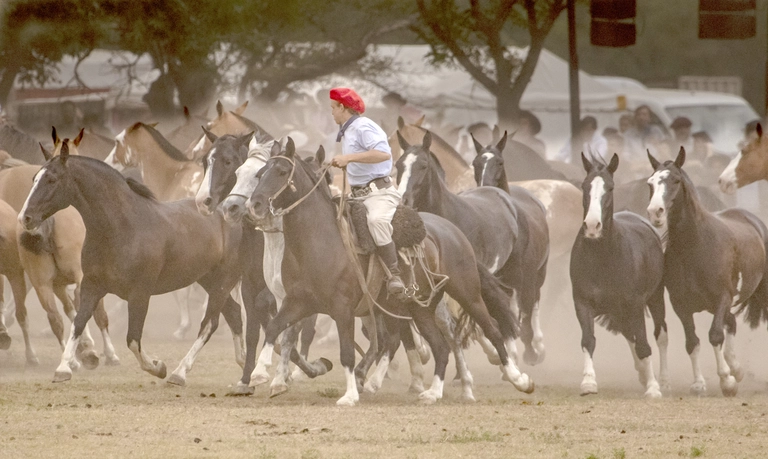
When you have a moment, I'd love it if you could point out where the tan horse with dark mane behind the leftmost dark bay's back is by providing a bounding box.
[105,122,203,201]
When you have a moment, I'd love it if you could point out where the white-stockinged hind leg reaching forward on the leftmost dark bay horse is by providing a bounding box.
[167,292,236,386]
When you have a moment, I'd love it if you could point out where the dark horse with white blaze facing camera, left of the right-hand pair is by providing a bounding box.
[571,153,668,398]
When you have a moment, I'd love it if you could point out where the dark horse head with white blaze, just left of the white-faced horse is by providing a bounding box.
[195,128,253,215]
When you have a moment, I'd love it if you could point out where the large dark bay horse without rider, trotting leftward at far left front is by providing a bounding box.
[19,144,243,382]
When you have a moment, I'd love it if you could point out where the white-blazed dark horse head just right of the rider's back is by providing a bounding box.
[395,131,445,208]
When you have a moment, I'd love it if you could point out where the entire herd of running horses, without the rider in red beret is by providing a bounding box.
[0,103,768,405]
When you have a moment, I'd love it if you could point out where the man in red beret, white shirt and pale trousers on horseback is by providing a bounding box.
[330,88,405,299]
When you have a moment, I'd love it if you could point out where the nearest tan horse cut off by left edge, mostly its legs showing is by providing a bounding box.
[0,200,31,366]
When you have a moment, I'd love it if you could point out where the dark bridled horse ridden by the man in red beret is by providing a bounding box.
[242,142,533,405]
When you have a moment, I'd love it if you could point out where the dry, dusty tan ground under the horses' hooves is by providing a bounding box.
[0,290,768,459]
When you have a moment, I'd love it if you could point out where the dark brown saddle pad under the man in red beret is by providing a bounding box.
[347,201,427,255]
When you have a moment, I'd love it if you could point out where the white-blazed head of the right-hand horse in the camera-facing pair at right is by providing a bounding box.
[648,147,687,231]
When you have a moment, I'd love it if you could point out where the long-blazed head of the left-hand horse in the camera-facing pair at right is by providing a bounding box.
[581,152,619,239]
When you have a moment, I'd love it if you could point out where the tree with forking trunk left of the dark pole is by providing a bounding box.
[414,0,566,126]
